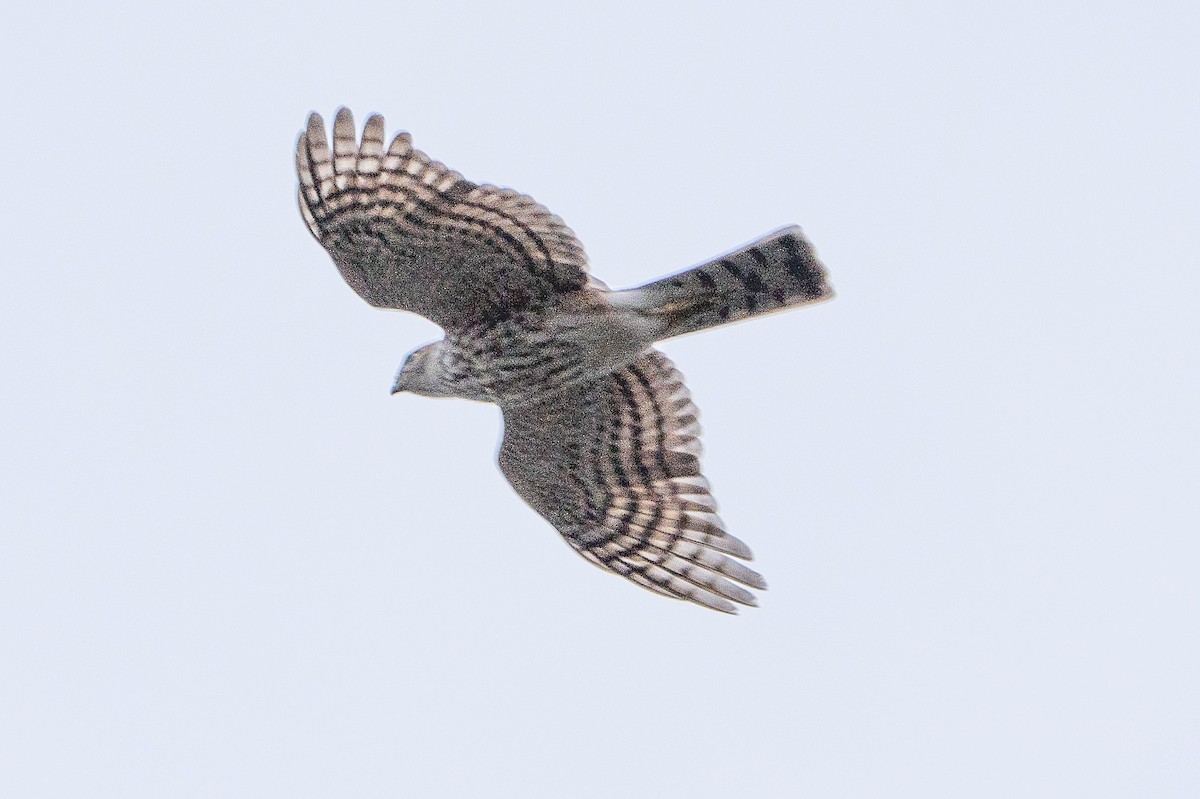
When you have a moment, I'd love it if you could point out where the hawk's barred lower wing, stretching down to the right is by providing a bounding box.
[500,350,767,613]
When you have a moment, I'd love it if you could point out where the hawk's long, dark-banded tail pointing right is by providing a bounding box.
[610,224,833,338]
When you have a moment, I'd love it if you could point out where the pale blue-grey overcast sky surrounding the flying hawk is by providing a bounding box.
[0,1,1200,799]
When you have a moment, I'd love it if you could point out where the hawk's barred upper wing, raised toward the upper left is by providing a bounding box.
[296,108,588,329]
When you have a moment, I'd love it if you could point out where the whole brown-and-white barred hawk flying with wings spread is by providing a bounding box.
[296,108,833,613]
